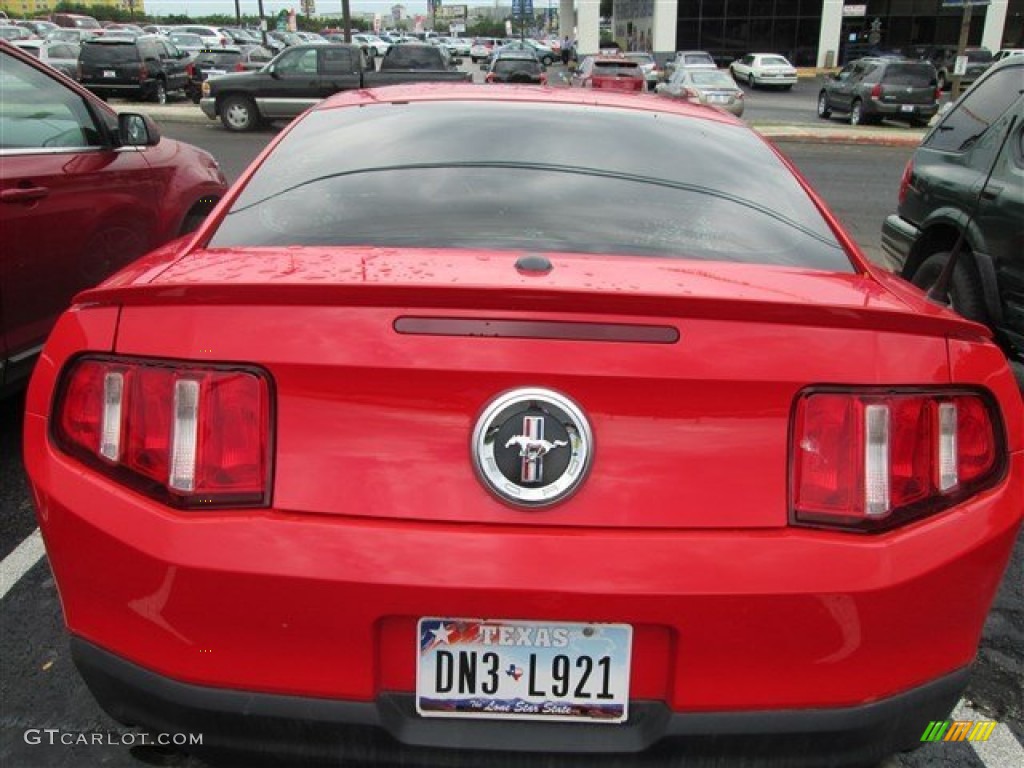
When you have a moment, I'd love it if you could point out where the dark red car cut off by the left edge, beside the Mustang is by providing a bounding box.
[0,43,227,393]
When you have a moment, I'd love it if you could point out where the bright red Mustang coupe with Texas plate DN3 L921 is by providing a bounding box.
[25,85,1024,766]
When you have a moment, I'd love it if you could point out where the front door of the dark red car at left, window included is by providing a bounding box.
[0,51,159,385]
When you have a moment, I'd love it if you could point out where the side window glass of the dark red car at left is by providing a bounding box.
[0,49,102,150]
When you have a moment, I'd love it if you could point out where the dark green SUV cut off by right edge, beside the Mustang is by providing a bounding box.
[882,56,1024,370]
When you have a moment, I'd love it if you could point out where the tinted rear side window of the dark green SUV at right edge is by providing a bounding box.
[925,67,1024,152]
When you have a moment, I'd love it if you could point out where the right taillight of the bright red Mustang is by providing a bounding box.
[791,391,1002,530]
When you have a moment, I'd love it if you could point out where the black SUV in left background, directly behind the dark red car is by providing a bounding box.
[78,35,191,104]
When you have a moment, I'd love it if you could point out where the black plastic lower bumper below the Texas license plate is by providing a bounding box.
[72,638,969,768]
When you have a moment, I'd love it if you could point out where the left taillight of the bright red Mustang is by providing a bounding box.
[53,357,271,508]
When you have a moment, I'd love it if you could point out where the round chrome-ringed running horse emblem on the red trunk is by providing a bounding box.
[472,388,594,507]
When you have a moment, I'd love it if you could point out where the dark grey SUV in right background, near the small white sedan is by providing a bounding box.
[818,57,942,126]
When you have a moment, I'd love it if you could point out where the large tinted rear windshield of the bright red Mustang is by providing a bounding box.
[210,100,853,272]
